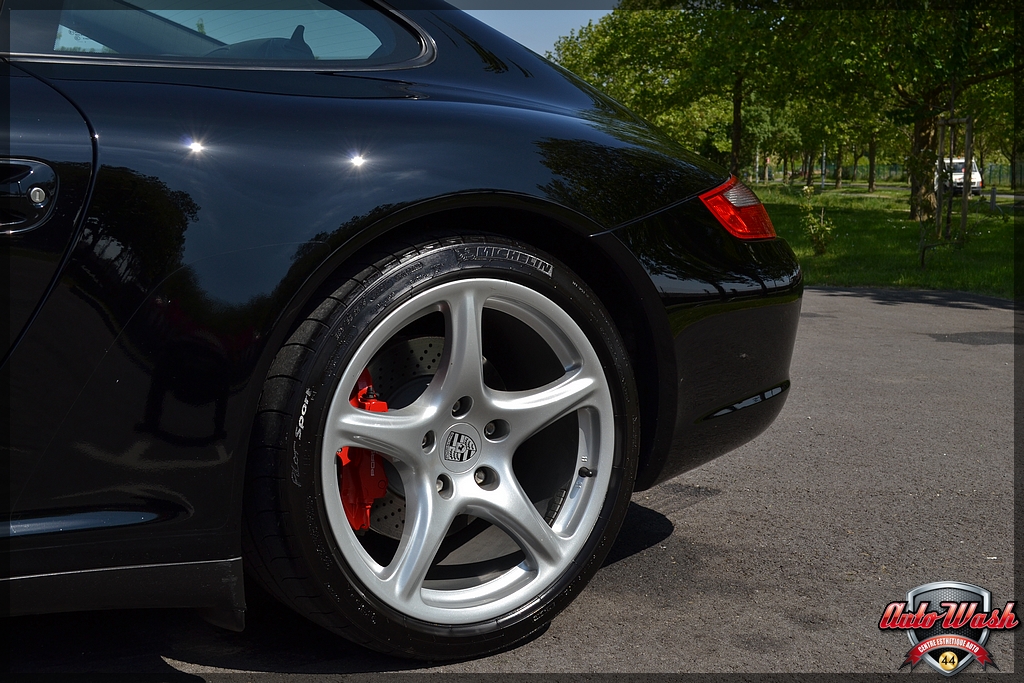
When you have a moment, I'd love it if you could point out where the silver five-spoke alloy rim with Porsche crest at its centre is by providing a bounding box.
[319,279,615,625]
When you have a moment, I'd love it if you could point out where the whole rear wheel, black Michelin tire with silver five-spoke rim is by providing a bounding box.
[244,236,639,660]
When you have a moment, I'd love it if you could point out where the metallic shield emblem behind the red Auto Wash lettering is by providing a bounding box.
[906,581,992,676]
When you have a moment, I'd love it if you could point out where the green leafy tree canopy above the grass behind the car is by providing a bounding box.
[550,5,1021,206]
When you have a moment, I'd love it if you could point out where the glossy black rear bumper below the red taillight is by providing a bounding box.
[614,197,803,489]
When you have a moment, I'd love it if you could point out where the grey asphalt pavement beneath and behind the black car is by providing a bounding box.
[5,290,1024,681]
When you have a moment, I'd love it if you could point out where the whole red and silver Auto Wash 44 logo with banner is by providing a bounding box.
[879,581,1019,676]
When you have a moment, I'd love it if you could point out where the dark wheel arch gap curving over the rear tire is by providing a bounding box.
[240,193,676,528]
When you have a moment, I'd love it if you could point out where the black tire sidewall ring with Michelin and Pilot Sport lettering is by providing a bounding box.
[283,238,639,658]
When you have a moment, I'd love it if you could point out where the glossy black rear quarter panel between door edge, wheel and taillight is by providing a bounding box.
[9,58,721,575]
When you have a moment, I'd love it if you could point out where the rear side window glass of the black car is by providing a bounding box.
[4,0,426,69]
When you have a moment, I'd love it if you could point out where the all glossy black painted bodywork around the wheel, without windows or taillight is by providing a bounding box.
[4,1,801,611]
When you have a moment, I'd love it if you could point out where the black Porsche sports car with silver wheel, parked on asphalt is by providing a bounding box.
[0,0,802,659]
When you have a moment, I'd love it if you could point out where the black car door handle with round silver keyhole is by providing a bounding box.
[0,159,57,233]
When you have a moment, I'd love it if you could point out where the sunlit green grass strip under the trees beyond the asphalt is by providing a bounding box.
[753,184,1014,299]
